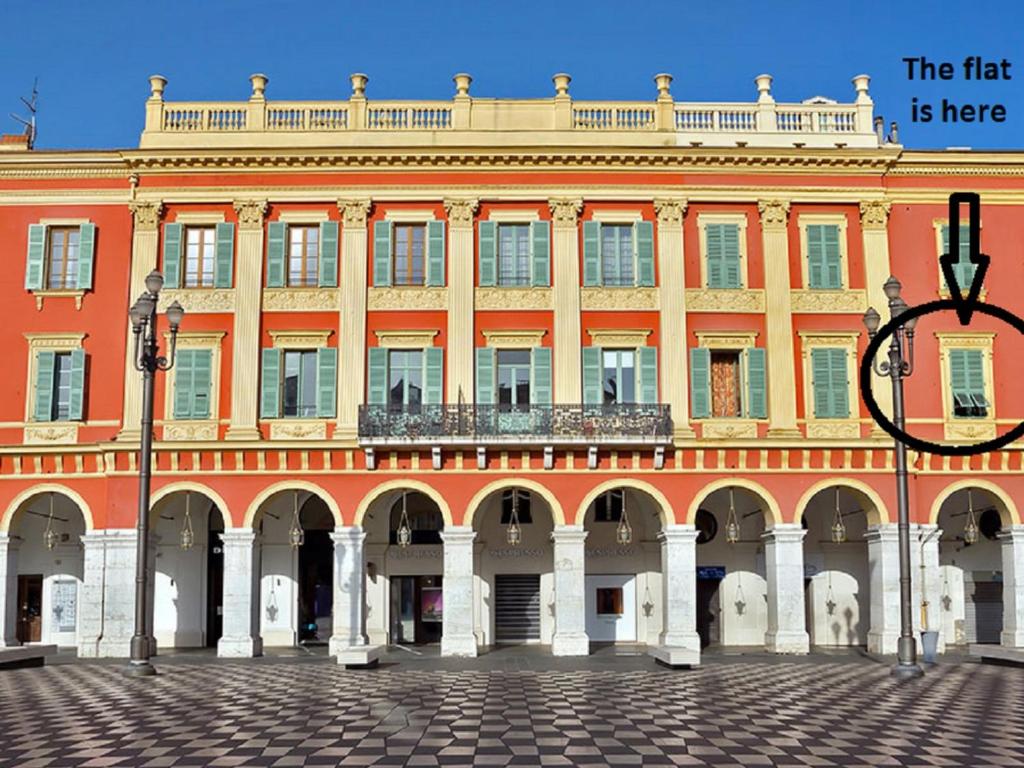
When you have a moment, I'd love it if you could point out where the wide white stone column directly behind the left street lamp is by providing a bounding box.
[78,528,135,658]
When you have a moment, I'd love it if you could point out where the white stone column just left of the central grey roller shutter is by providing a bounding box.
[441,525,476,656]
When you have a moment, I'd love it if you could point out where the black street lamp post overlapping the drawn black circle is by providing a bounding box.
[864,278,924,678]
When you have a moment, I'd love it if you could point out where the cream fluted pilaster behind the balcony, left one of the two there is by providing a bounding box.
[444,200,479,403]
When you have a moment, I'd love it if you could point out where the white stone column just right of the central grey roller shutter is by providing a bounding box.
[551,525,590,656]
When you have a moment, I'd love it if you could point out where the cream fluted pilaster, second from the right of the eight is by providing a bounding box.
[758,200,800,437]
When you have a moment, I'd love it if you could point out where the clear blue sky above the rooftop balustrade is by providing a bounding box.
[0,0,1024,148]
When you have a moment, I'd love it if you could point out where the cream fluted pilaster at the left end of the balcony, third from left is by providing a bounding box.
[334,200,372,441]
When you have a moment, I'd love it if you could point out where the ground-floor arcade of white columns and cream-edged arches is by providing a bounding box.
[0,474,1024,656]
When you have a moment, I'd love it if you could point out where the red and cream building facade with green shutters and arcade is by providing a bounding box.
[0,75,1024,656]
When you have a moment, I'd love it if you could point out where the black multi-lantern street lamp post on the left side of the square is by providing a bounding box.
[127,269,185,675]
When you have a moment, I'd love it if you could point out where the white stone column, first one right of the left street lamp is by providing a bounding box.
[217,528,263,657]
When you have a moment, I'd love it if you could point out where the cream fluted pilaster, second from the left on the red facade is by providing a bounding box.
[225,200,267,440]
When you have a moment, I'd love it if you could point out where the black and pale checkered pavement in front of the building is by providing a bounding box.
[0,657,1024,768]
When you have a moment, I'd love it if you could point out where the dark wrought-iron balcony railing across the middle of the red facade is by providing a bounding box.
[359,403,672,445]
